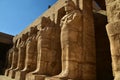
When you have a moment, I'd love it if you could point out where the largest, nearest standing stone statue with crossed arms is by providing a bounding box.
[45,0,83,80]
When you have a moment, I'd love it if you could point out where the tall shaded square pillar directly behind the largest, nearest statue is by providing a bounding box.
[82,0,96,80]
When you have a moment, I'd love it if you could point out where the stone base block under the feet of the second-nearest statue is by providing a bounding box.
[26,73,46,80]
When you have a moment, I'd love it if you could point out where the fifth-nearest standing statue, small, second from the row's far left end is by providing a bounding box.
[5,39,20,76]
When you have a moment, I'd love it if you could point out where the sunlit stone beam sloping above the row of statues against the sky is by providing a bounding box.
[14,0,83,39]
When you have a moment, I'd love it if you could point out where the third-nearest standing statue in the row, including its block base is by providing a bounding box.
[15,26,38,80]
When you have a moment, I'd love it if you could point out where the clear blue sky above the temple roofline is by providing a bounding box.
[0,0,57,35]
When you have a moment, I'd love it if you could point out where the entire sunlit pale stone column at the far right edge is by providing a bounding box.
[106,0,120,80]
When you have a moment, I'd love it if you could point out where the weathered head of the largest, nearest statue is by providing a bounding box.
[65,0,75,12]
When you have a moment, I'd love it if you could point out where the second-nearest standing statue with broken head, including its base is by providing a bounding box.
[27,17,61,80]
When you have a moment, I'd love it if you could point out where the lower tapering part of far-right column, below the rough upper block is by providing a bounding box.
[106,21,120,80]
